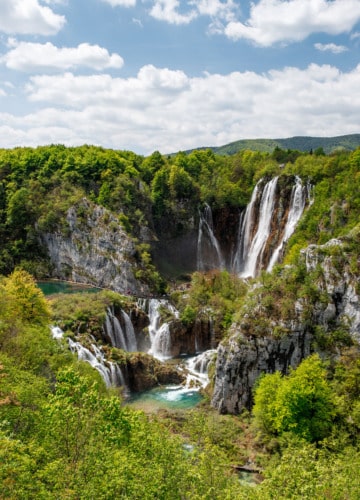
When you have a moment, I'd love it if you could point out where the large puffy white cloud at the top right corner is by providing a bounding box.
[224,0,360,47]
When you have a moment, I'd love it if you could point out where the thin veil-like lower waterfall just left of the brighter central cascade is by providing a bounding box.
[104,307,137,352]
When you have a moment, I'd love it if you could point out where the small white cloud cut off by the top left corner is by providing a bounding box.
[0,0,66,35]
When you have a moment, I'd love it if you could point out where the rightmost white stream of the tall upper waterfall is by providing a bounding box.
[267,176,307,271]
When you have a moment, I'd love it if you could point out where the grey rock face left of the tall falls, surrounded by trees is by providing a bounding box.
[40,199,148,294]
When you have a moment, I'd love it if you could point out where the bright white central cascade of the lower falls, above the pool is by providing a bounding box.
[148,299,179,360]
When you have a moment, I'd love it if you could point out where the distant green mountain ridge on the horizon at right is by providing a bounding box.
[188,134,360,155]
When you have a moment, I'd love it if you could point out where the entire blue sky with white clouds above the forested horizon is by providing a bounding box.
[0,0,360,156]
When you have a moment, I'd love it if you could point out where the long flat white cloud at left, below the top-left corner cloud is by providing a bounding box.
[0,39,124,72]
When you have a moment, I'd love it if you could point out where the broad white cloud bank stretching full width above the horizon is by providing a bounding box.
[0,64,360,154]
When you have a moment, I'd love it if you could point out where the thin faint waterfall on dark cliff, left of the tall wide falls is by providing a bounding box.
[197,204,225,271]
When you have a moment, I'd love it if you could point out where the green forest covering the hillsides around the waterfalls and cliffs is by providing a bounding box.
[0,145,360,500]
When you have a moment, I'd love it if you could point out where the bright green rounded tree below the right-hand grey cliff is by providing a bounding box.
[253,355,336,442]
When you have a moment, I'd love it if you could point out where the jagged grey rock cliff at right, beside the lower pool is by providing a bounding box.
[212,236,360,414]
